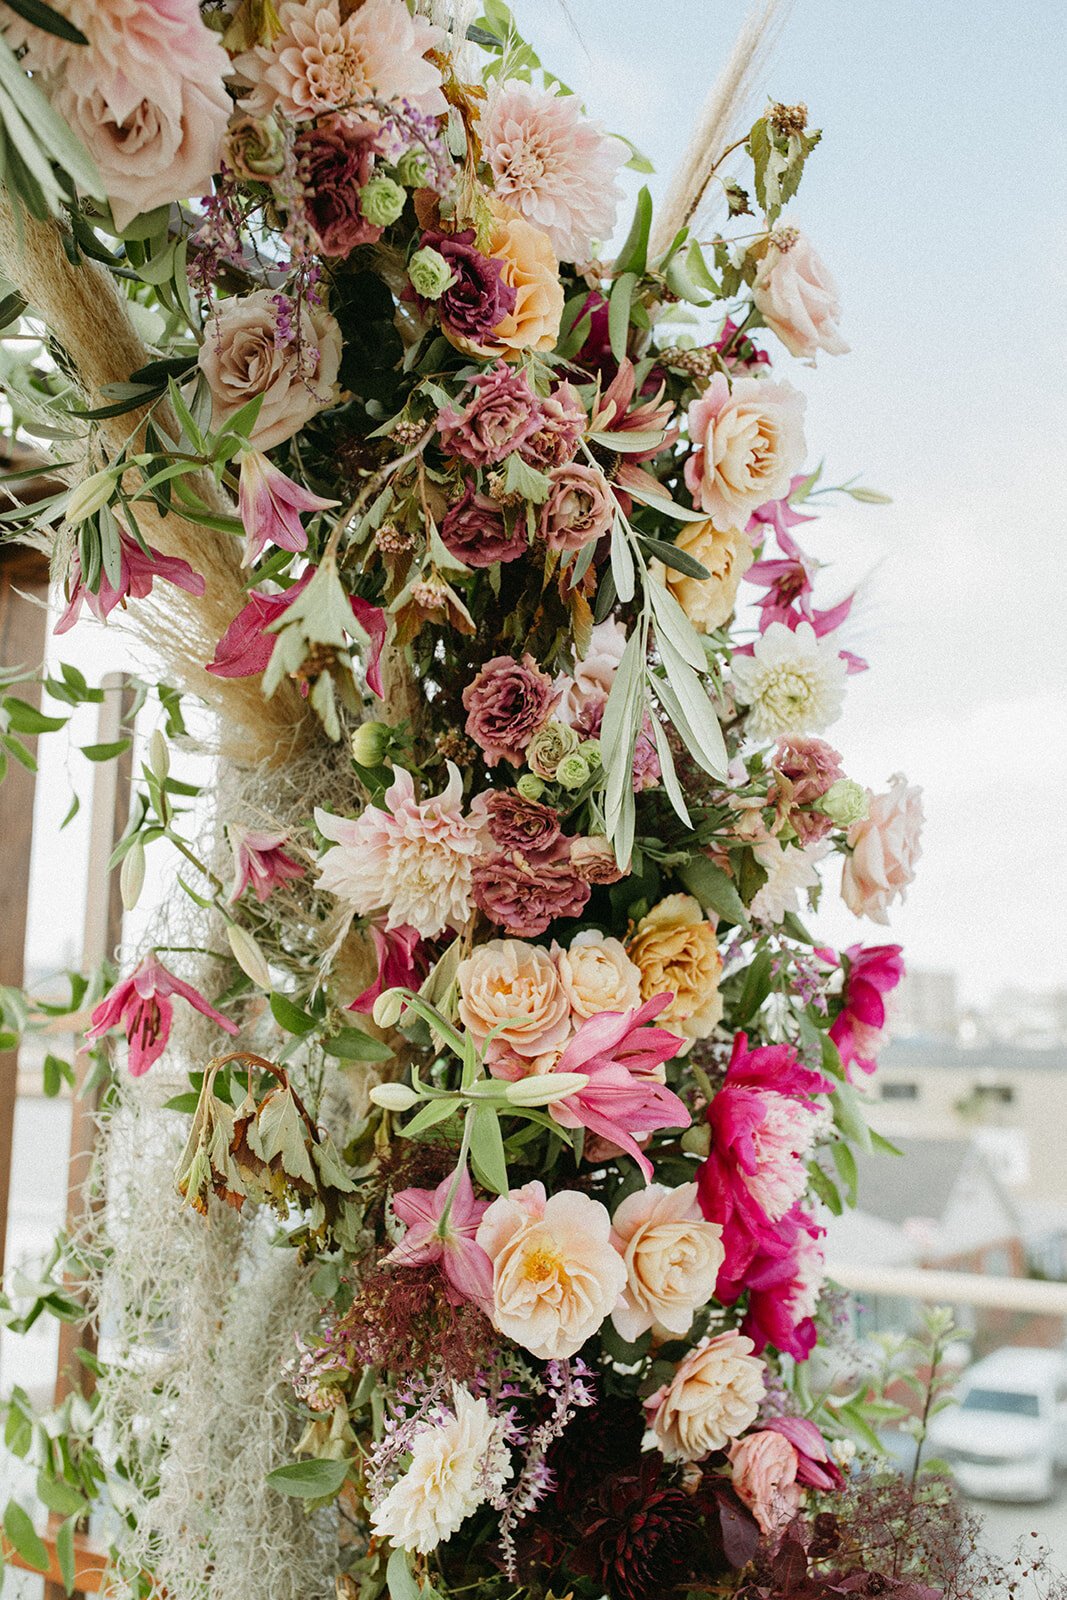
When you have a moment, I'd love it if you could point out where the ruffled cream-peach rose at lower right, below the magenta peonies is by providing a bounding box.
[645,1331,765,1461]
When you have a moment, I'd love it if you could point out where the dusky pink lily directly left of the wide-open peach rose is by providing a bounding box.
[386,1166,493,1315]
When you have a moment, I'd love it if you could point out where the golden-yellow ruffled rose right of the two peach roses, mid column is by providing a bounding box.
[629,894,723,1040]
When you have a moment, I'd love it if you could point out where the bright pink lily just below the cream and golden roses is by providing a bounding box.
[549,994,693,1179]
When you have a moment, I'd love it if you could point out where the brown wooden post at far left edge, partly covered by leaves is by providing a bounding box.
[0,544,48,1274]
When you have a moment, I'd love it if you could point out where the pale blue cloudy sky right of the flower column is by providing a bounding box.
[517,0,1067,1000]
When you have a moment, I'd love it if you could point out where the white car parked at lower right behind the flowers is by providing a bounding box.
[928,1346,1067,1501]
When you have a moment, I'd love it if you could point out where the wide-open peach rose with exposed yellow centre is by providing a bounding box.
[477,1182,625,1362]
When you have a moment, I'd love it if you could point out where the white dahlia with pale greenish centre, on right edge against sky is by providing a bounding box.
[733,622,848,744]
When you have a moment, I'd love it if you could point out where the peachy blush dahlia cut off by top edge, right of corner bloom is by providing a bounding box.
[234,0,446,122]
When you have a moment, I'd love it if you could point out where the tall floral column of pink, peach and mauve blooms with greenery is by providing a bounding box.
[0,0,934,1600]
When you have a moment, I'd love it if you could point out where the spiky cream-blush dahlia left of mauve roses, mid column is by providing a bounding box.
[315,762,478,939]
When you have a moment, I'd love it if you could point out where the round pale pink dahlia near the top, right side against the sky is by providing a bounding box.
[480,80,627,261]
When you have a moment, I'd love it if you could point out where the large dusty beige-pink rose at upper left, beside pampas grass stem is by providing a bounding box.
[197,290,341,450]
